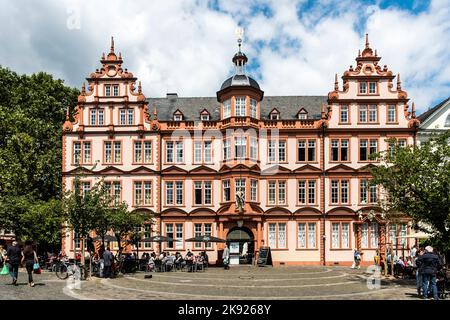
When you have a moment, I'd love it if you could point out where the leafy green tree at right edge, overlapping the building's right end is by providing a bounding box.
[371,130,450,258]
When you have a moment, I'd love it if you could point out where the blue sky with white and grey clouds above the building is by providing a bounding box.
[0,0,450,111]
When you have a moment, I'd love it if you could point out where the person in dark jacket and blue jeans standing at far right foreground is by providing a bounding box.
[417,246,442,300]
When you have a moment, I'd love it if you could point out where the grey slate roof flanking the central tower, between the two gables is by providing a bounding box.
[147,94,327,121]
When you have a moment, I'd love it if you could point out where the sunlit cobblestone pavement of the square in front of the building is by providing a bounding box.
[0,267,424,300]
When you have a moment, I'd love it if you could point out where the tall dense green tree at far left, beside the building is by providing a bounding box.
[0,66,79,243]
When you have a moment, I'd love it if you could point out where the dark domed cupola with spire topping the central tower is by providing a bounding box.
[217,28,264,102]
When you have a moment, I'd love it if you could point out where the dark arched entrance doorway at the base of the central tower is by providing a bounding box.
[227,227,255,264]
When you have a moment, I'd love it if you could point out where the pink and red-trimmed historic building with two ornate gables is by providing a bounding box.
[62,36,419,265]
